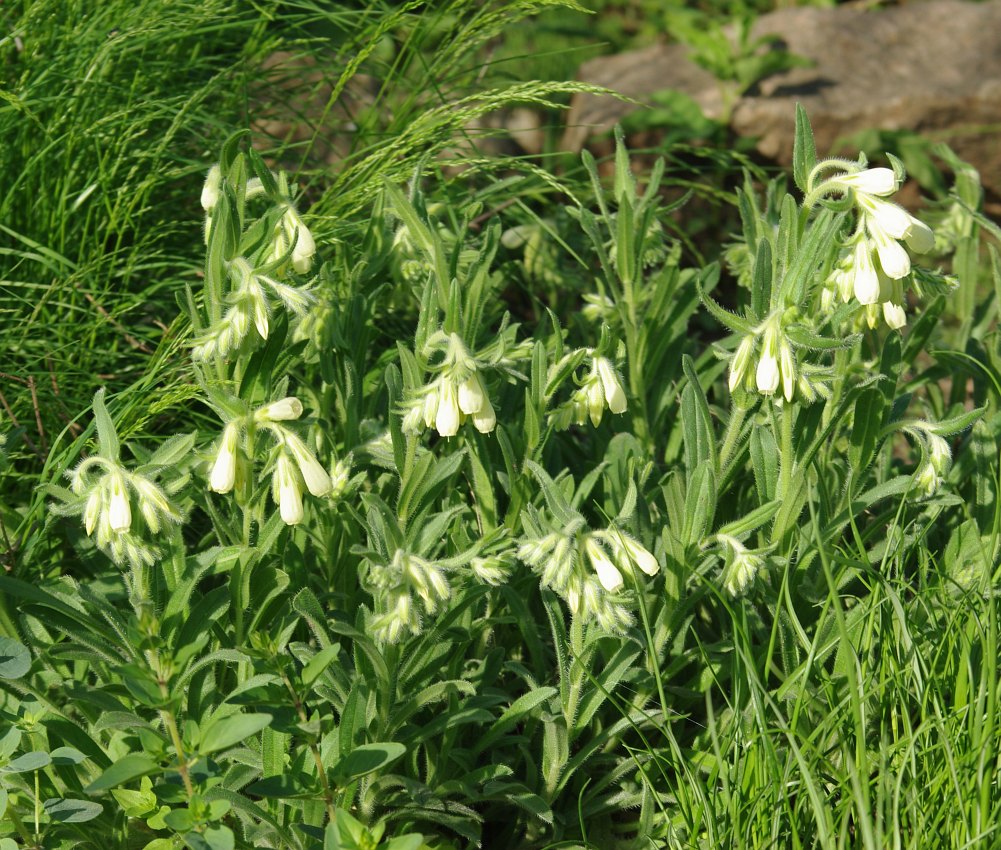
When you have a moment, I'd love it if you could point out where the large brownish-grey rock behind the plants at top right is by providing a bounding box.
[564,0,1001,195]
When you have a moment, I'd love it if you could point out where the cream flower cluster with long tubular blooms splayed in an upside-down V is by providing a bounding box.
[208,396,333,526]
